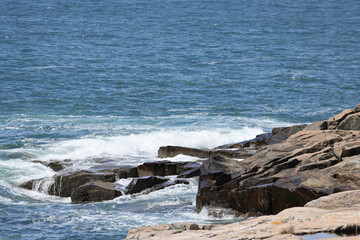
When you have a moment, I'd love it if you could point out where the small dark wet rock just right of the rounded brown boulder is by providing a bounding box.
[126,176,170,194]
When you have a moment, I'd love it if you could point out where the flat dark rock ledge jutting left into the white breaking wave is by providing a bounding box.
[158,146,209,158]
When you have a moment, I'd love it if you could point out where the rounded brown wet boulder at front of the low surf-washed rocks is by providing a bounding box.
[71,181,122,203]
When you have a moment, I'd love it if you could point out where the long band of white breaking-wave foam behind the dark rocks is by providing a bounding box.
[31,127,263,160]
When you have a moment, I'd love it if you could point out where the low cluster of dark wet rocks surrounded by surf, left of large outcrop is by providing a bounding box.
[20,161,200,203]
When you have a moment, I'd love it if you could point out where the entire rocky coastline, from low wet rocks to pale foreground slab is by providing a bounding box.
[21,103,360,239]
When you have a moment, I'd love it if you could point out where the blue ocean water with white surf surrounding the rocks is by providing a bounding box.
[0,0,360,239]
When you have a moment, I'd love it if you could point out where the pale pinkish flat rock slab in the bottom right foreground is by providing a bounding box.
[126,207,360,240]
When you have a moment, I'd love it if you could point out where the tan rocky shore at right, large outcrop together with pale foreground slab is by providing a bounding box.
[126,103,360,240]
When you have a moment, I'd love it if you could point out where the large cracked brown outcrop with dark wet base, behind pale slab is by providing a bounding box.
[196,102,360,214]
